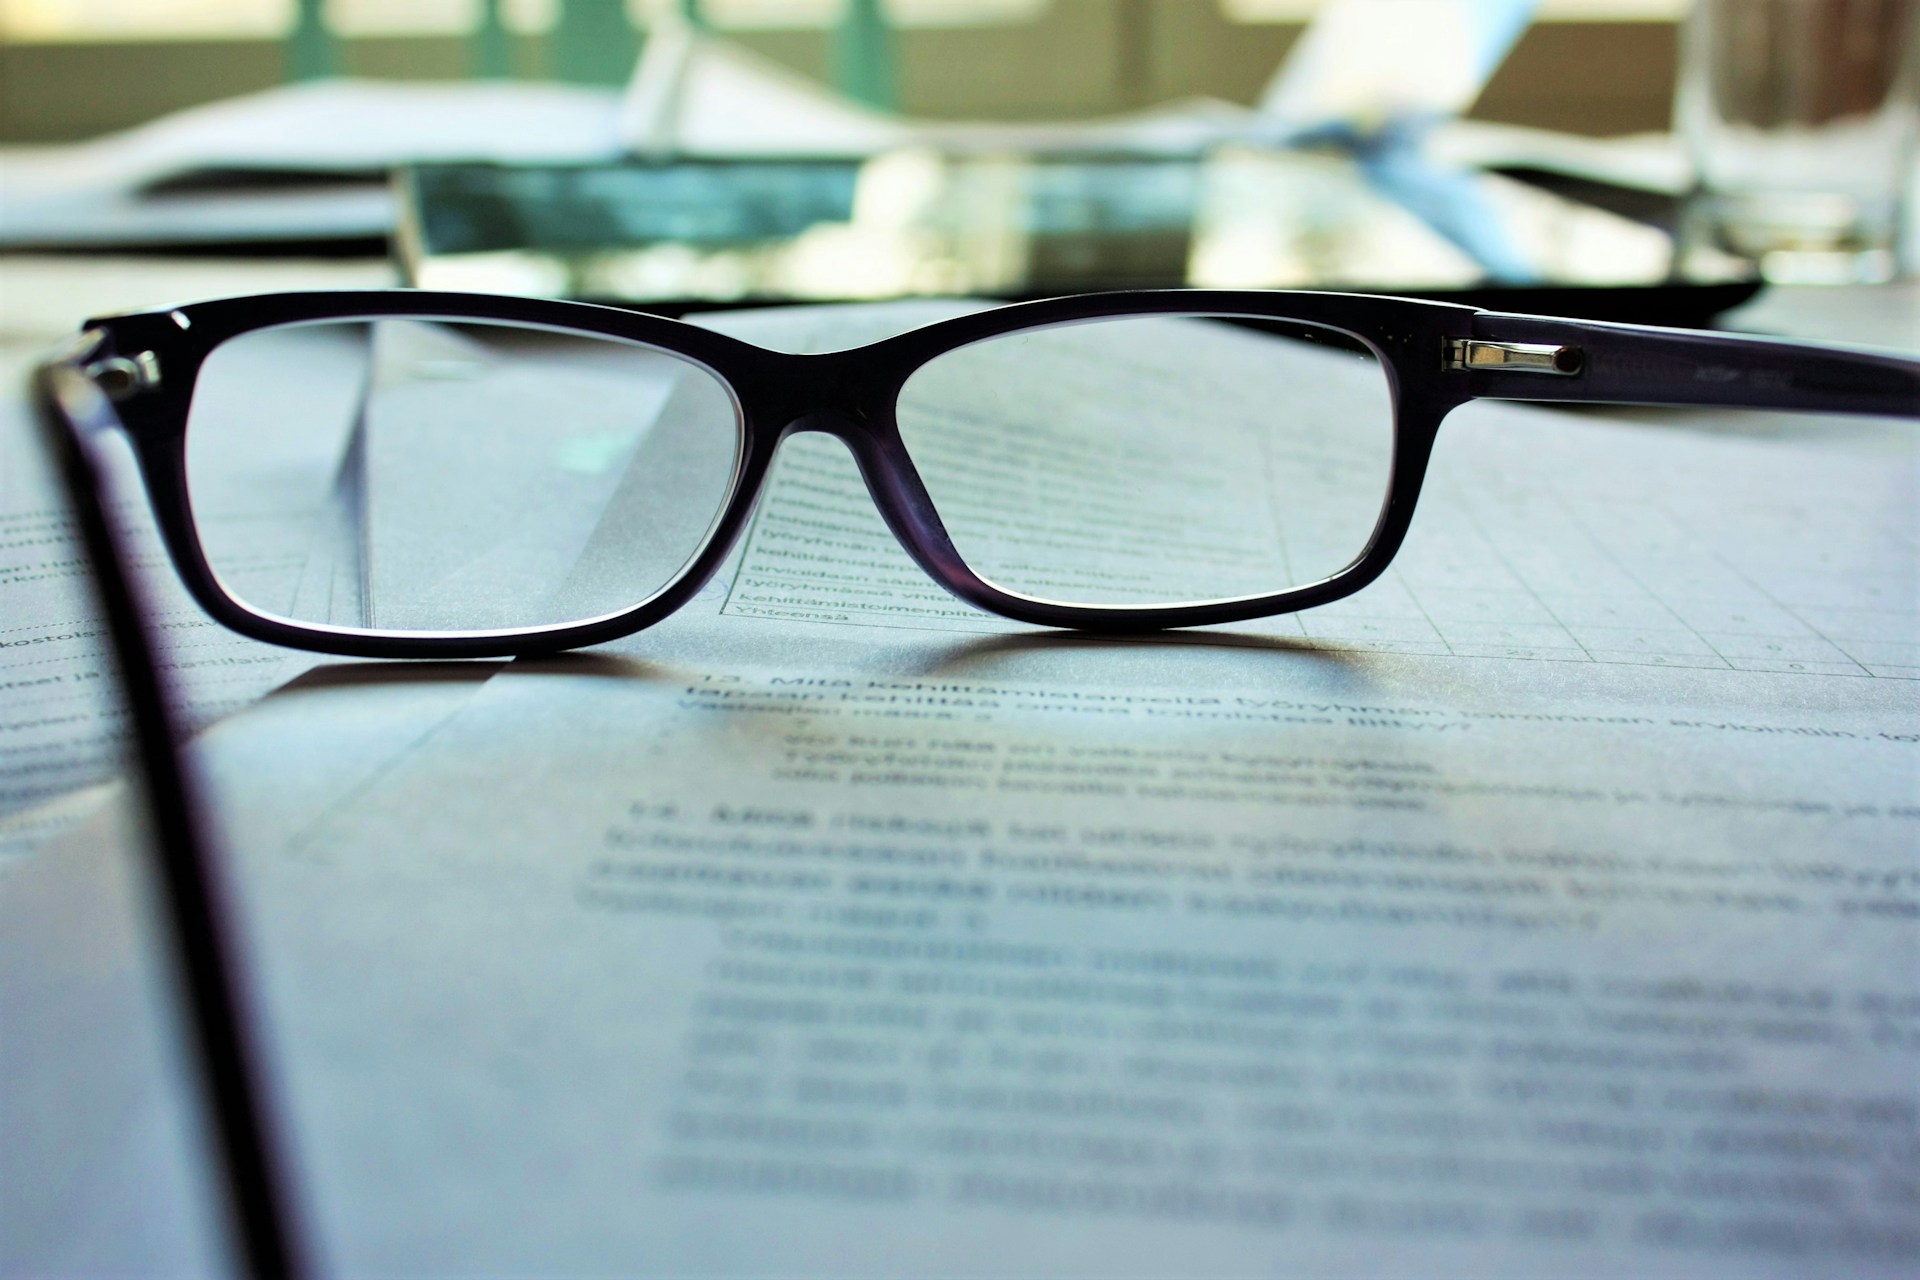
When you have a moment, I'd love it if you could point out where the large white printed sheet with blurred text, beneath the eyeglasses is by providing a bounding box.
[7,297,1920,1278]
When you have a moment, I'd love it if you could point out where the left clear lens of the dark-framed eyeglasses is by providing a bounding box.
[186,319,741,631]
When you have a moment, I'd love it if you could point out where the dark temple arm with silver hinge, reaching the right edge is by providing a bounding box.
[1442,311,1920,418]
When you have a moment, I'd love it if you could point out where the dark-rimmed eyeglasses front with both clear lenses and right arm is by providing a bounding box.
[40,290,1920,658]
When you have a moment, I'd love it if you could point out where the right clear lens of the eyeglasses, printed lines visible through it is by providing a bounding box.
[899,317,1394,606]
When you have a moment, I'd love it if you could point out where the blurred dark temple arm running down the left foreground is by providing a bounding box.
[29,343,309,1278]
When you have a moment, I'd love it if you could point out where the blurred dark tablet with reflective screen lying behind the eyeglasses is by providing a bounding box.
[396,148,1759,326]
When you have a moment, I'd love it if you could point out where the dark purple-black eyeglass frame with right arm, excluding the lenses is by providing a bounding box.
[42,290,1920,658]
